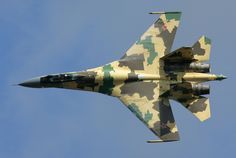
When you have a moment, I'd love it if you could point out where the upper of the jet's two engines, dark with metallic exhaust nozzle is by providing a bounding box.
[164,62,210,73]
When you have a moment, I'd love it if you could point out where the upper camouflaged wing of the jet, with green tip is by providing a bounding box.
[121,12,181,71]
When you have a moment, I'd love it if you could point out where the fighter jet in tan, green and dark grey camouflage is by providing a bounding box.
[19,12,226,143]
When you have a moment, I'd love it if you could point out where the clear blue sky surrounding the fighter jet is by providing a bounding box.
[0,0,236,158]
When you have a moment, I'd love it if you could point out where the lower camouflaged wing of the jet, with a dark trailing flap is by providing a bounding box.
[119,81,179,141]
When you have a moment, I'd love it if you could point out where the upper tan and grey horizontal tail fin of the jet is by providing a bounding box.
[192,36,211,61]
